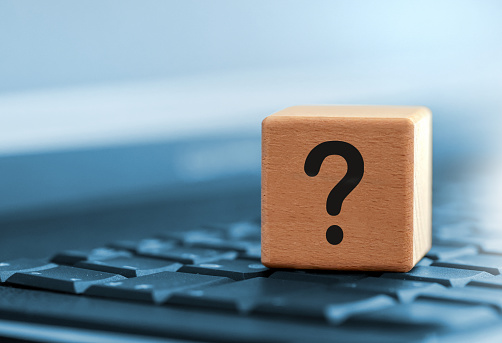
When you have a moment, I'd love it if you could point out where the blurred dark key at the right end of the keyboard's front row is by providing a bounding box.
[353,300,498,329]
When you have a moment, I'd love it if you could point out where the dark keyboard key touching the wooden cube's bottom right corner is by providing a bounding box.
[382,266,490,287]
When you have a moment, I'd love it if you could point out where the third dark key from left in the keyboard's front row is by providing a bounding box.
[168,278,320,313]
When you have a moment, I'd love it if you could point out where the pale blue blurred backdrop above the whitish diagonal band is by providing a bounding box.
[0,0,502,92]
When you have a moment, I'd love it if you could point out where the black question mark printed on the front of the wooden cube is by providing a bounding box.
[304,141,364,245]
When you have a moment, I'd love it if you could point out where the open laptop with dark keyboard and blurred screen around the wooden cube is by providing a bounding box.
[0,68,502,342]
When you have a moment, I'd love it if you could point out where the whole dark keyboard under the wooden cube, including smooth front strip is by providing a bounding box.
[0,218,502,342]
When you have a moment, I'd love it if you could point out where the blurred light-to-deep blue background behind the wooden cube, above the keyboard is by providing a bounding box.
[0,0,502,227]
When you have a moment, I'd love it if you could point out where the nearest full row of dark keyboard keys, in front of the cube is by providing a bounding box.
[4,258,502,327]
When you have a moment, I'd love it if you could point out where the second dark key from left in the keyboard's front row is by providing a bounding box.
[85,272,232,303]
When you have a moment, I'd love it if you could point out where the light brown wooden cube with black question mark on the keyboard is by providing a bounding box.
[262,106,432,272]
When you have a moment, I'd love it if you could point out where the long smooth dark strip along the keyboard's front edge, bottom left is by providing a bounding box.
[0,287,364,342]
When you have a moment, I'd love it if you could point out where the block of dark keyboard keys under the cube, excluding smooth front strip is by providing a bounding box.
[0,220,502,337]
